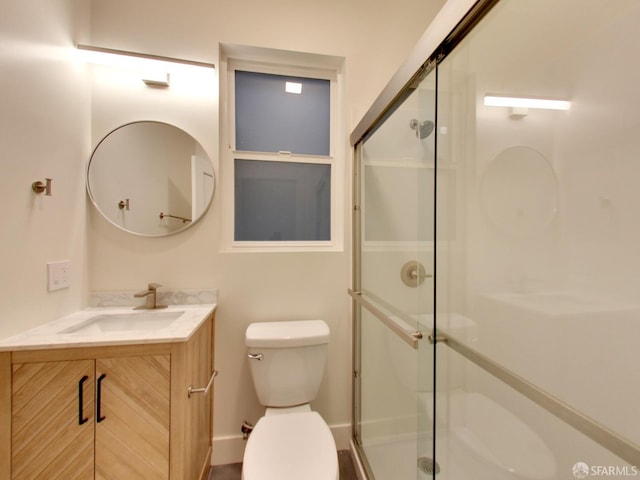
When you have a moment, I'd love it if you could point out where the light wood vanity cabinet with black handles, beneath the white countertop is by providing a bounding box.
[0,315,214,480]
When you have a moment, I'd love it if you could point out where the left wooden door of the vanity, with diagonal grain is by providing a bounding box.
[11,360,94,480]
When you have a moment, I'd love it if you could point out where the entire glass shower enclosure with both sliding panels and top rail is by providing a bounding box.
[349,0,640,480]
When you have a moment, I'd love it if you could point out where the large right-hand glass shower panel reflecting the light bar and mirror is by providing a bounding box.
[436,0,640,480]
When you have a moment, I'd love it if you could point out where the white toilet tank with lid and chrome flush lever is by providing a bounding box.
[245,320,329,407]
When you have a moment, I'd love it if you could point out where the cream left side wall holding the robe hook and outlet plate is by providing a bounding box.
[0,0,90,337]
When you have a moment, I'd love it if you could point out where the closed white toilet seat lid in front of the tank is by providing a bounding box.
[242,412,339,480]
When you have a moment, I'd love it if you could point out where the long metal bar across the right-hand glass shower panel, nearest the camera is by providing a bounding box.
[438,329,640,465]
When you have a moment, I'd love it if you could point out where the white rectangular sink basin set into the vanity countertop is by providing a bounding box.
[59,311,184,335]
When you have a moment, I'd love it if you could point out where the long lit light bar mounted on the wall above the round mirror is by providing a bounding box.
[77,45,215,87]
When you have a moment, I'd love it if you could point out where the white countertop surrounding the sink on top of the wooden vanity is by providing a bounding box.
[0,303,217,351]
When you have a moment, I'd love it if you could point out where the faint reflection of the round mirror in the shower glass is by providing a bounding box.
[480,146,558,236]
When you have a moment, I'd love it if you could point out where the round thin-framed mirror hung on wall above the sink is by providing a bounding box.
[87,121,215,237]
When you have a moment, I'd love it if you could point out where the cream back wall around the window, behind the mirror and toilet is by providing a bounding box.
[88,0,444,463]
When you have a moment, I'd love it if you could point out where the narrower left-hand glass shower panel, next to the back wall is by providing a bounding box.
[353,65,435,480]
